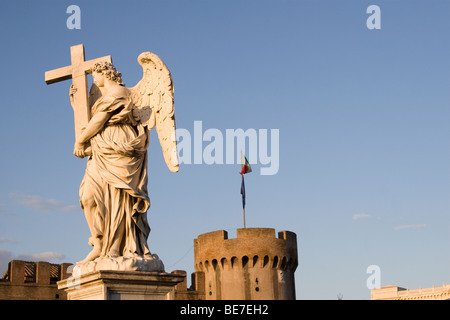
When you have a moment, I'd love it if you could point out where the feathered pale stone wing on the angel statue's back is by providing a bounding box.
[128,52,179,172]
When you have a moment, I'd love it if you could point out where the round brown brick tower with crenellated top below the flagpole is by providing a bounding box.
[194,228,298,300]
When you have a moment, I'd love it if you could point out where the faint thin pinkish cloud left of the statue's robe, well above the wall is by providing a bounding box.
[9,193,80,212]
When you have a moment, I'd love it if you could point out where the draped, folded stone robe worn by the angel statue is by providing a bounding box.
[80,86,150,256]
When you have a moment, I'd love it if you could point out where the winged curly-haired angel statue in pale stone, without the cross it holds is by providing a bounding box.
[70,52,179,271]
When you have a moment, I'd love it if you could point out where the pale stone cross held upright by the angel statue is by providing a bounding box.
[45,44,112,139]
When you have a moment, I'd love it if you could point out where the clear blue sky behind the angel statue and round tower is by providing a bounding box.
[0,0,450,299]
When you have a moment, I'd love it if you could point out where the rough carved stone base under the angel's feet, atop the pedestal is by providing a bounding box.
[72,254,164,277]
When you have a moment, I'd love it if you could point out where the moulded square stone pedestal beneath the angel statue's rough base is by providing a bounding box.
[58,270,185,300]
